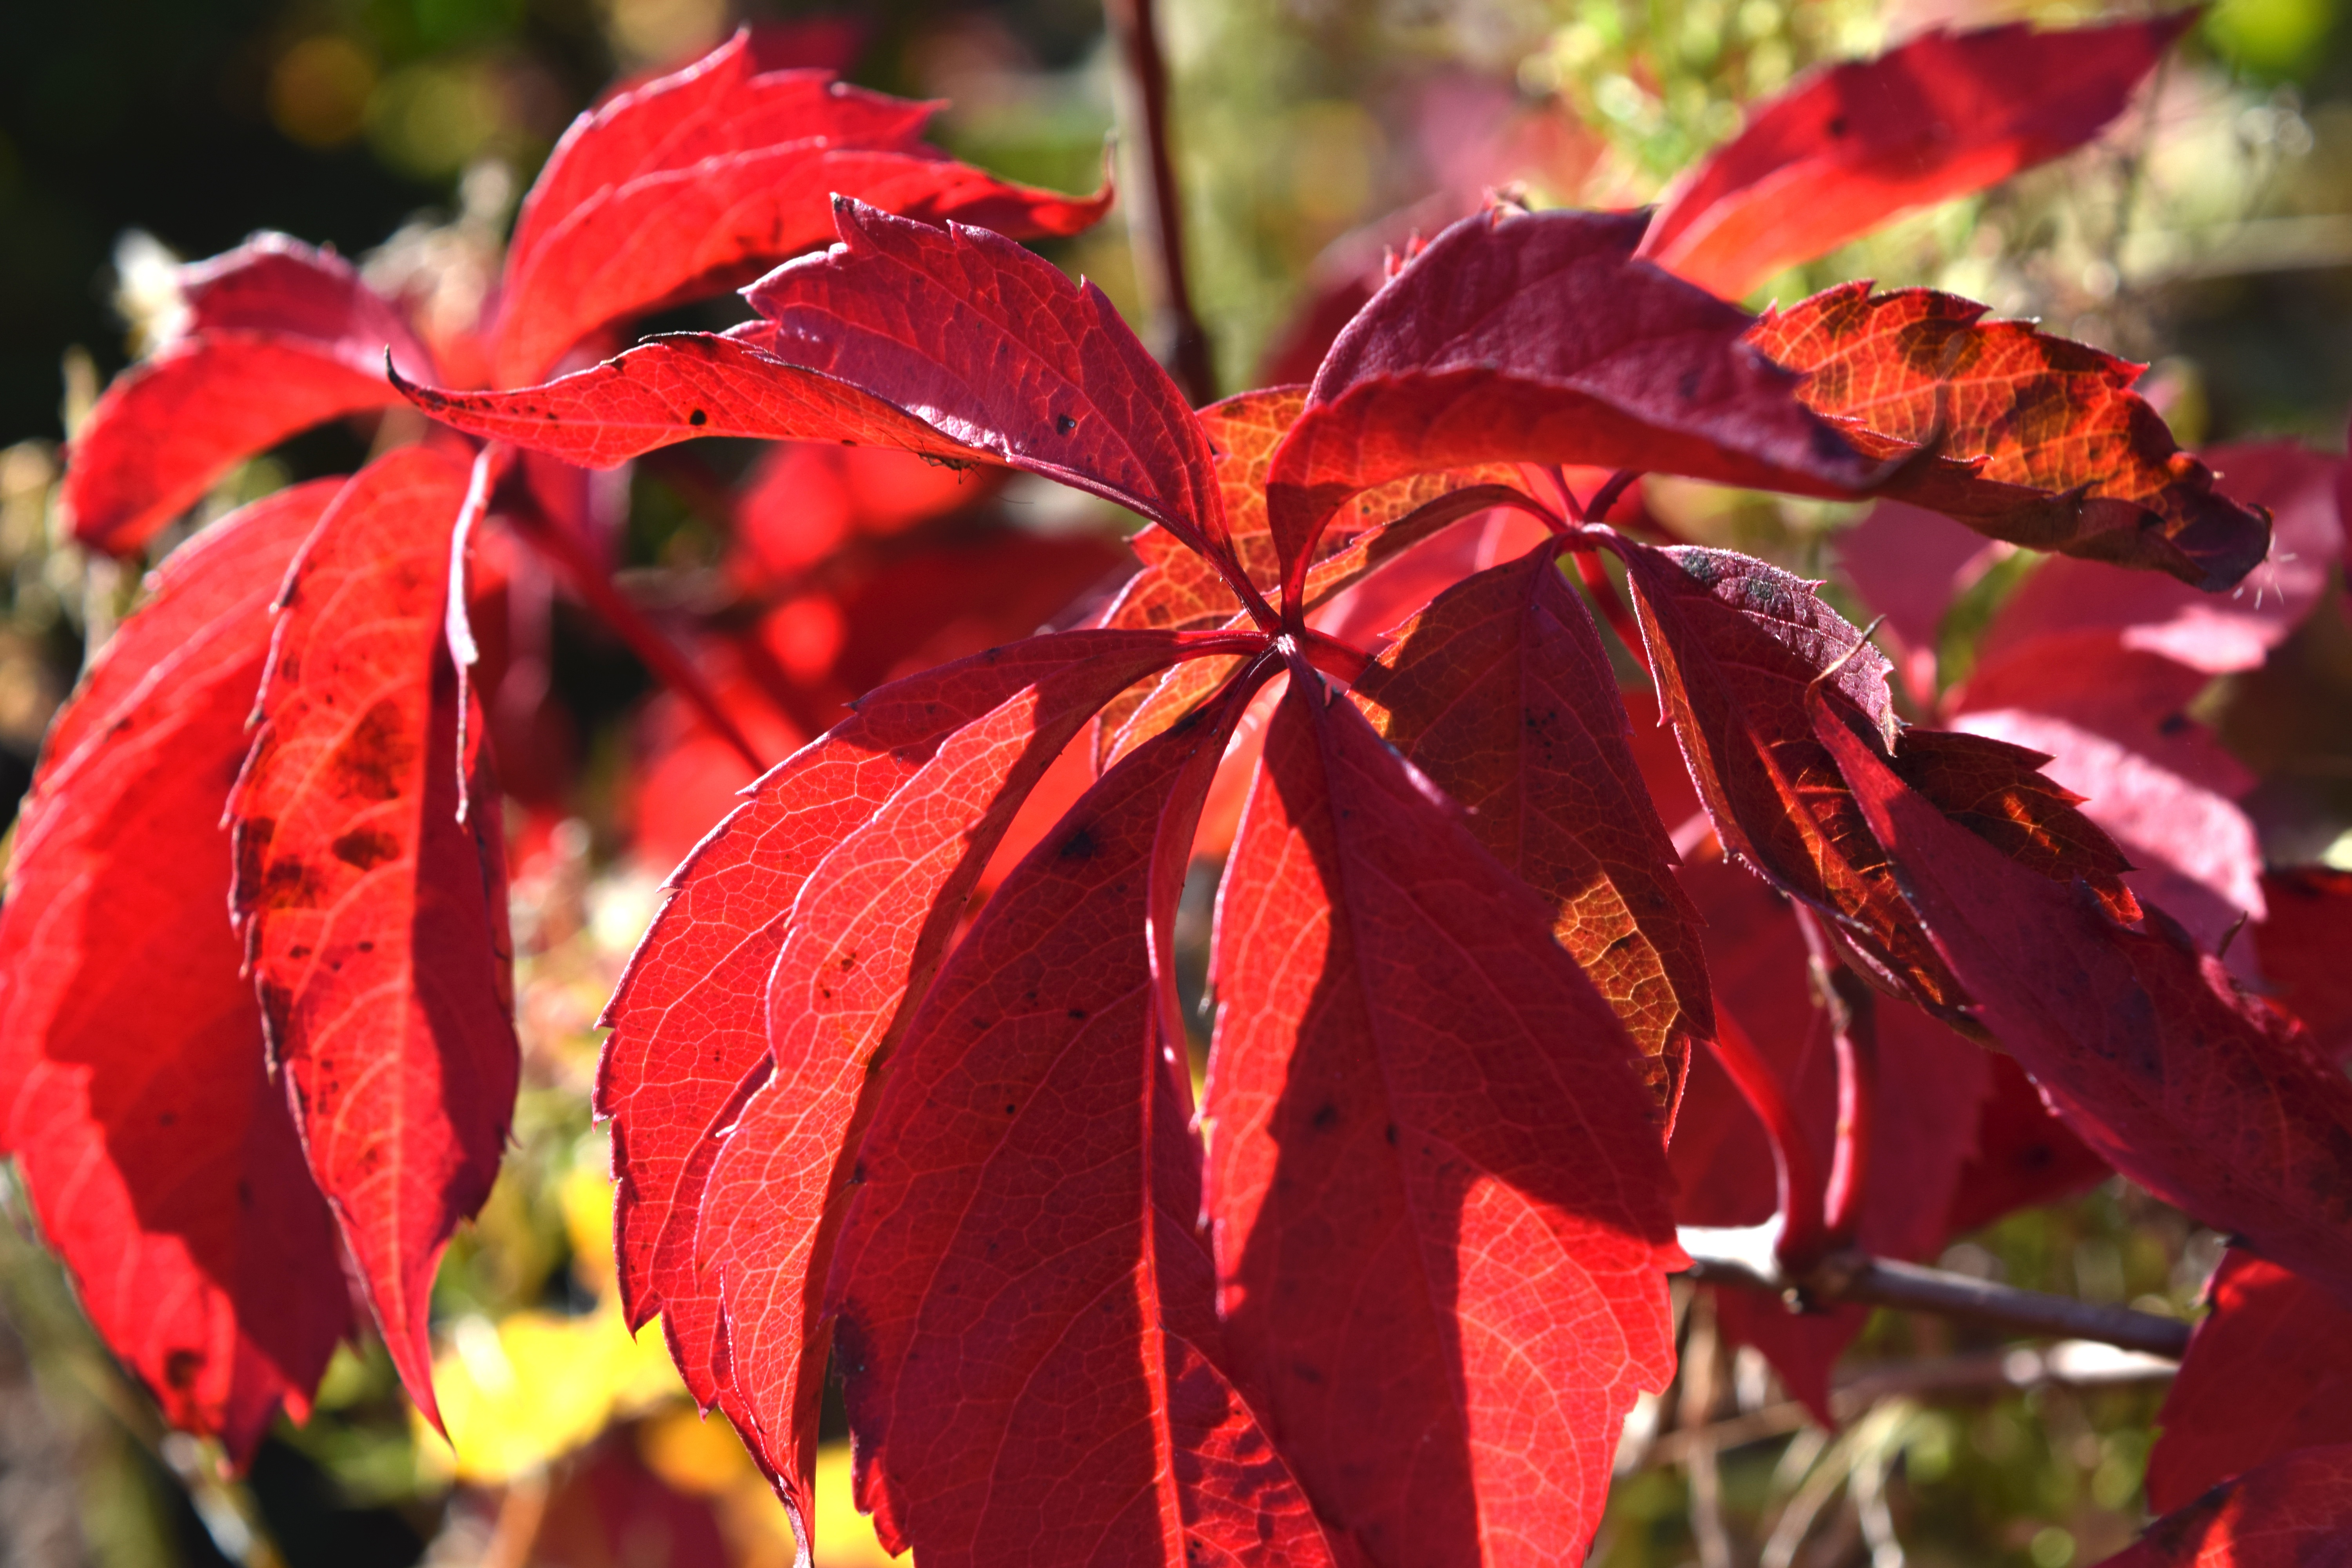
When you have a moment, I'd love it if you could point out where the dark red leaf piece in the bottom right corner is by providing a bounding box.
[2100,1443,2352,1568]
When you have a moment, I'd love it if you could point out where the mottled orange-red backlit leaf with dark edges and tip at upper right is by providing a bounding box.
[1748,282,2270,592]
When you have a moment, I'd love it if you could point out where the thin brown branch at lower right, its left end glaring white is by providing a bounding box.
[1682,1229,2190,1361]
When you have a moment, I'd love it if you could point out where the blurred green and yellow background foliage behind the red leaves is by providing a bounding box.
[0,0,2352,1568]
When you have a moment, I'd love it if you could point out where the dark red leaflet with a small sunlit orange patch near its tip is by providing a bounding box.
[1355,548,1715,1122]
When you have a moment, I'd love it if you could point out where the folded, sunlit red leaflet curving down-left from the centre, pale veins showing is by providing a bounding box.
[597,632,1251,1519]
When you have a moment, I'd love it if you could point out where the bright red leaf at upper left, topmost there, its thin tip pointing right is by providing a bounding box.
[494,33,1110,386]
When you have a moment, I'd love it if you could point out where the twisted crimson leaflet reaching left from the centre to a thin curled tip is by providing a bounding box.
[395,198,1225,573]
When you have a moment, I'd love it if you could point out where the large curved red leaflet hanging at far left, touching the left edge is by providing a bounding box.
[0,479,350,1462]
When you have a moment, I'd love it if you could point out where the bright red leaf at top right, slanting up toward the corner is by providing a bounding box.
[1642,12,2194,299]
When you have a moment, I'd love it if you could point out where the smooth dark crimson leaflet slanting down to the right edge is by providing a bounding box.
[1809,693,2352,1298]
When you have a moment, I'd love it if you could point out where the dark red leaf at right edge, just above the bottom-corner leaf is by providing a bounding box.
[2147,1250,2352,1514]
